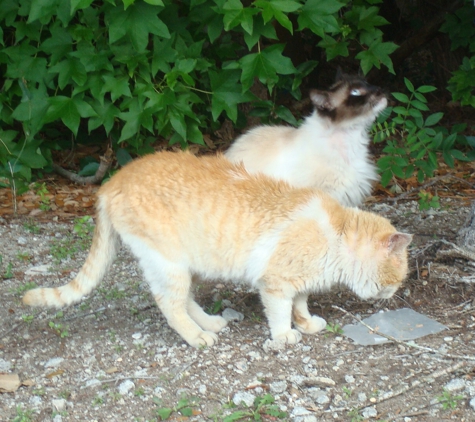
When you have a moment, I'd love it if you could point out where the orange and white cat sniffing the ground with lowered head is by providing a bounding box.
[23,152,412,347]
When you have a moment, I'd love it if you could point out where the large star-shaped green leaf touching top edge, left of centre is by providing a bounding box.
[106,2,170,53]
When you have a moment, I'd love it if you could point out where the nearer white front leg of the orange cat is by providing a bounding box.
[260,287,302,344]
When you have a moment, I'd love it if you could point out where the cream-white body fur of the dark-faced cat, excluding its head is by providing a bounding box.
[225,98,387,206]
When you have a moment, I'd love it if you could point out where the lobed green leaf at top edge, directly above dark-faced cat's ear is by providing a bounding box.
[298,0,344,38]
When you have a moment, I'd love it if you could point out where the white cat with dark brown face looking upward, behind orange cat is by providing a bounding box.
[225,72,387,206]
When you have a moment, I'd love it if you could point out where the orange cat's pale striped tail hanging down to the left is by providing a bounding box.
[23,198,119,308]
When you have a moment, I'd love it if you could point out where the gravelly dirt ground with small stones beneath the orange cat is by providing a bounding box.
[0,193,475,422]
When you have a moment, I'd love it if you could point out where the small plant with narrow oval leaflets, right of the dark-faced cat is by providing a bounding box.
[372,78,475,186]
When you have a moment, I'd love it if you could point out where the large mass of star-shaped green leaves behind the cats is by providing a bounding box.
[0,0,402,190]
